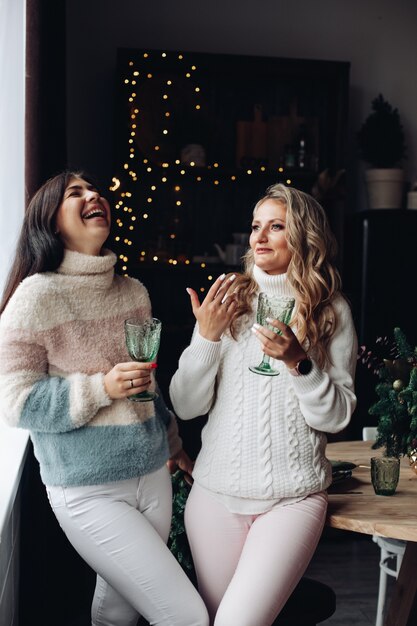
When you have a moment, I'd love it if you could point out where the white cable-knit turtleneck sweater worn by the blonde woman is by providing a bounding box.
[170,266,357,501]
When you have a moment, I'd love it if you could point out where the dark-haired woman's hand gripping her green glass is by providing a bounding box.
[104,361,156,400]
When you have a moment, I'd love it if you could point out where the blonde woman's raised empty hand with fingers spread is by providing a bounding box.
[187,274,237,341]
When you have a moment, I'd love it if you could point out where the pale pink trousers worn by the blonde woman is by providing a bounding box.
[185,483,327,626]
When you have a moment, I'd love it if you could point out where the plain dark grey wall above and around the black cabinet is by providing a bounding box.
[67,0,417,208]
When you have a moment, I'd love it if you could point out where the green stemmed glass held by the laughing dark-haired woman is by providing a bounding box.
[125,317,162,402]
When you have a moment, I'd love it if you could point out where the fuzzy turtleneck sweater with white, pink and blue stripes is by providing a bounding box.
[0,250,181,486]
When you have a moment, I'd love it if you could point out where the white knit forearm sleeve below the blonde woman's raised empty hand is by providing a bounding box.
[169,326,221,420]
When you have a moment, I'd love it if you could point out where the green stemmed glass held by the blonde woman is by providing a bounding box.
[249,293,295,376]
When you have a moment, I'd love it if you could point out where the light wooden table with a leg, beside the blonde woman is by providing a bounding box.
[326,441,417,626]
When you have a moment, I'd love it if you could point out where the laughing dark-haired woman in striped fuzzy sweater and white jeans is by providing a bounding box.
[0,172,208,626]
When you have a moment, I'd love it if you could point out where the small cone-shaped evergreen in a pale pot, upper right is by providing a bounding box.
[358,94,406,209]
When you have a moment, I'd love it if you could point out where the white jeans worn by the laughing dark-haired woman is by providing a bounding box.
[47,467,208,626]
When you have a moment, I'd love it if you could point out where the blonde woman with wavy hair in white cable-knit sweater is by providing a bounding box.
[170,184,357,626]
